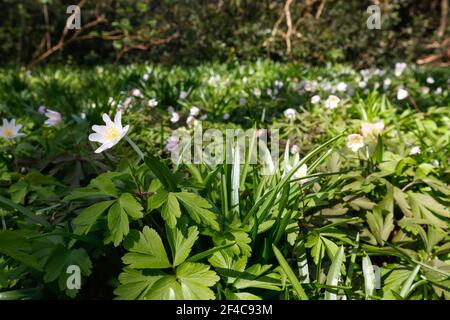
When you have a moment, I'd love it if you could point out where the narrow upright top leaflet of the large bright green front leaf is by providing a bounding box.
[168,226,199,267]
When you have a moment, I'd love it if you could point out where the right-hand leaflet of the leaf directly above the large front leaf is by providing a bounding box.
[175,192,220,231]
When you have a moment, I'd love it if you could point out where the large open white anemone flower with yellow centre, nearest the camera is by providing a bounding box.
[89,111,130,153]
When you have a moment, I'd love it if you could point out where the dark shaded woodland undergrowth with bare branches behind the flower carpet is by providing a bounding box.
[0,0,450,67]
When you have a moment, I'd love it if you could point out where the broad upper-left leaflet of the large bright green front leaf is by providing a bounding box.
[122,226,172,269]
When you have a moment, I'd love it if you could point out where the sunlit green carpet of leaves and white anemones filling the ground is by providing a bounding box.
[0,61,450,300]
